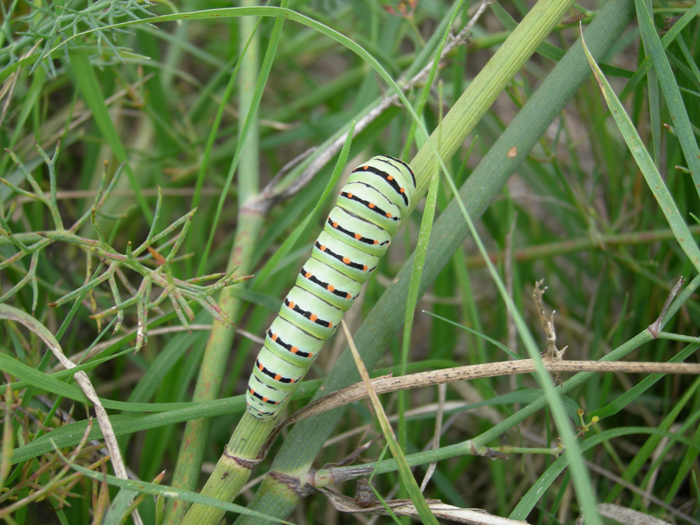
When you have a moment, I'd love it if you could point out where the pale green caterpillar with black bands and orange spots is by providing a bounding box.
[246,155,416,420]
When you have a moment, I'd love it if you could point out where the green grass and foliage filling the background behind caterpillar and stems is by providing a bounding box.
[0,0,700,523]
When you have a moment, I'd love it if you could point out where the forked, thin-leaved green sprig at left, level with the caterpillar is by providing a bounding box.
[0,145,247,350]
